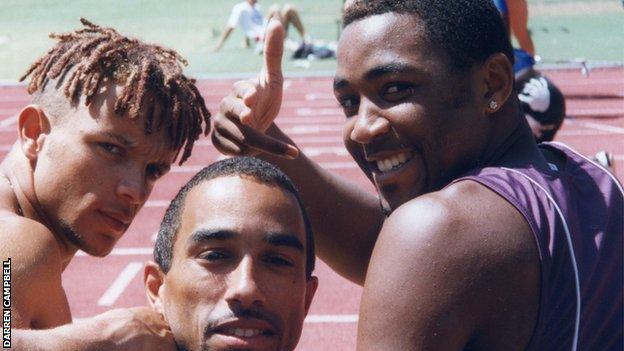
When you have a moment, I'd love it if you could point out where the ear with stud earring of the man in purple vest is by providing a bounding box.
[483,52,514,114]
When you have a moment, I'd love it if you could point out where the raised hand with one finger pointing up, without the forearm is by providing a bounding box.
[212,20,299,158]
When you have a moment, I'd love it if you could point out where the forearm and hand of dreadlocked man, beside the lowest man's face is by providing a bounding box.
[12,307,176,351]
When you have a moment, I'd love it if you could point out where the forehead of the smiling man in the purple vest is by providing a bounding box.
[336,13,446,77]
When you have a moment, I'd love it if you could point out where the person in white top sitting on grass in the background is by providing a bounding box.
[213,0,306,51]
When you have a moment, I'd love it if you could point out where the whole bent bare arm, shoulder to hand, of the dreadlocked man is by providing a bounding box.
[0,216,175,350]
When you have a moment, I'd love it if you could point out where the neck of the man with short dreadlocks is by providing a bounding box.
[0,143,78,269]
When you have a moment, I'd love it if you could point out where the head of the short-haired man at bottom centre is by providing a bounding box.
[144,157,318,350]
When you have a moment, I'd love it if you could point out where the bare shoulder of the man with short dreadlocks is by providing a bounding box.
[0,215,71,328]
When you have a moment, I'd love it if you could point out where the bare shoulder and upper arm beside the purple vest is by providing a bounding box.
[357,182,540,351]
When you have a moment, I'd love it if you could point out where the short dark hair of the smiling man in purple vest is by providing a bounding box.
[343,0,514,72]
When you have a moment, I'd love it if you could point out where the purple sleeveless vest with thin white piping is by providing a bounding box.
[454,143,624,350]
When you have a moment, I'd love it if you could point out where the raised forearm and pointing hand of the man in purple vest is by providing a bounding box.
[212,21,384,284]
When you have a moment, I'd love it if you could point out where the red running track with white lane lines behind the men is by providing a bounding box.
[0,69,624,350]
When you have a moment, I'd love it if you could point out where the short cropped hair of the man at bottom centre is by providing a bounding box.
[154,157,315,279]
